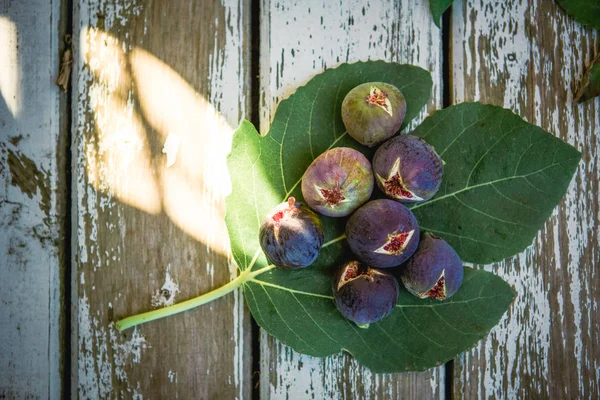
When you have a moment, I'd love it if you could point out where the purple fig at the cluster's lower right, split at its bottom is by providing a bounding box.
[401,232,464,300]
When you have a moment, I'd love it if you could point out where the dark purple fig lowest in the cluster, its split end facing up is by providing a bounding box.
[333,261,399,328]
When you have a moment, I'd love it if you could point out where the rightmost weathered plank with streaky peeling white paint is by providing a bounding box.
[451,0,600,398]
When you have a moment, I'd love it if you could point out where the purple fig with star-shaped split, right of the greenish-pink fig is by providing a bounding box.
[373,135,444,203]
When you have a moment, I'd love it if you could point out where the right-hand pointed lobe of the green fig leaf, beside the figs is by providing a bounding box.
[412,103,581,263]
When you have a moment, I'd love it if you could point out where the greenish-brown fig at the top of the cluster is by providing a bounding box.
[342,82,406,147]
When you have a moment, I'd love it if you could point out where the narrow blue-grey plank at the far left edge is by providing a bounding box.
[0,1,66,399]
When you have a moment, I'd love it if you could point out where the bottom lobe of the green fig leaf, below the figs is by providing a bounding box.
[244,264,515,373]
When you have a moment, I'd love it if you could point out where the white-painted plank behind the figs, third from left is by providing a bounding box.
[260,0,444,399]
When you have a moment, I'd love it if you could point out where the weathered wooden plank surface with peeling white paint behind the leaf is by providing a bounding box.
[0,0,600,399]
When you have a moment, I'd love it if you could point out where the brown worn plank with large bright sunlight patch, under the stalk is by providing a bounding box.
[72,0,251,399]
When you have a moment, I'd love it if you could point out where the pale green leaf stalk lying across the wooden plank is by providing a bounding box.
[116,235,346,332]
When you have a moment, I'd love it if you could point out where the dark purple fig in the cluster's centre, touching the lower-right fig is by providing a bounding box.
[346,199,419,268]
